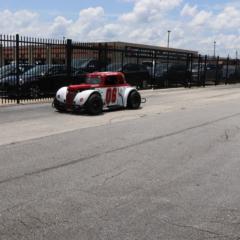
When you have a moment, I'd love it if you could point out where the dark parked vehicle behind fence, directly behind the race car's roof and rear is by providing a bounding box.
[107,63,151,88]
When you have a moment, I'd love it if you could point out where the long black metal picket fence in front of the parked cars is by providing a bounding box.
[0,35,240,103]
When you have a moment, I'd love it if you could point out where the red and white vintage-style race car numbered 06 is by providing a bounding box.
[53,72,141,115]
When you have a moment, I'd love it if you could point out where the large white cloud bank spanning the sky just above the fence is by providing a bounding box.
[0,0,240,55]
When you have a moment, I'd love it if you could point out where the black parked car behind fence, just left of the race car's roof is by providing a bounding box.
[19,64,86,98]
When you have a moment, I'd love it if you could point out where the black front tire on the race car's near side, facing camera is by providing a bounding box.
[86,94,103,115]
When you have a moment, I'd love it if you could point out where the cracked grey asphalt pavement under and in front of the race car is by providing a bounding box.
[0,85,240,240]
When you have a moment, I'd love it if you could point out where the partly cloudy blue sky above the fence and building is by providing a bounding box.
[0,0,240,58]
